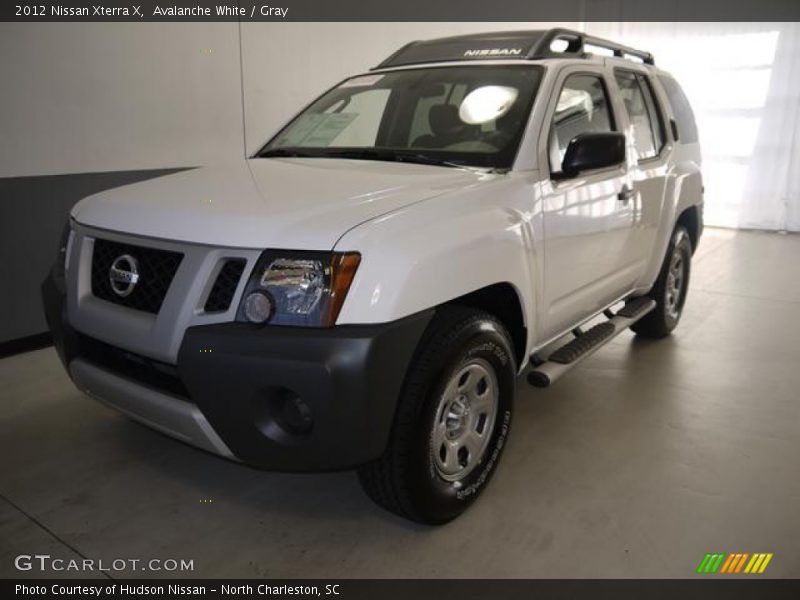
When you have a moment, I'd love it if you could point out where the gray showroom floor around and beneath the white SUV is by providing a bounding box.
[0,229,800,577]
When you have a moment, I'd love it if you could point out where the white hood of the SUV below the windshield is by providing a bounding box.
[72,158,496,250]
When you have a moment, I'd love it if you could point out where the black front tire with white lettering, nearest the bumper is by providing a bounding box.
[358,306,516,524]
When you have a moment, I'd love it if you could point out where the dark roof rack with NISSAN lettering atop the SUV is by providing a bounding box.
[375,28,655,69]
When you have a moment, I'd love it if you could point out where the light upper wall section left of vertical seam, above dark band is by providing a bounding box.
[0,23,242,177]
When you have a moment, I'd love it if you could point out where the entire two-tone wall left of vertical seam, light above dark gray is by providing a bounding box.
[0,23,244,343]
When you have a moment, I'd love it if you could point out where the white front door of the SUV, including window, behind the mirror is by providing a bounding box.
[539,65,639,339]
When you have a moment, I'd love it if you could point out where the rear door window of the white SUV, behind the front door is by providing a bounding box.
[614,69,664,160]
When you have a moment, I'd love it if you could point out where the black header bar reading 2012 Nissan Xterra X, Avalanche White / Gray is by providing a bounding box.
[0,0,800,22]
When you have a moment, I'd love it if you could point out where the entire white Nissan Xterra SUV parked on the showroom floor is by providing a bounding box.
[43,29,703,523]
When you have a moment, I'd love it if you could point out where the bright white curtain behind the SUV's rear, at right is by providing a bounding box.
[584,22,800,231]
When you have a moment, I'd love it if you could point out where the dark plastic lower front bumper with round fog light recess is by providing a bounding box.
[42,275,433,471]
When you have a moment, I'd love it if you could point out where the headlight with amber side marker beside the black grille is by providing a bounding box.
[236,250,361,327]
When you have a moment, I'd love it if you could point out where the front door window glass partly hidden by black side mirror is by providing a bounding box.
[549,74,614,173]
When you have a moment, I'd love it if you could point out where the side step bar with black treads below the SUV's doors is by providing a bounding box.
[528,296,656,388]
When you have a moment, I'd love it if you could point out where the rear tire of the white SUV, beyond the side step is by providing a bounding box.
[631,225,692,339]
